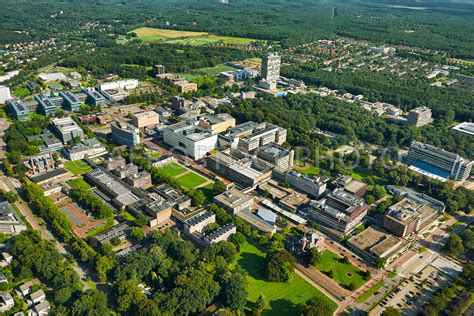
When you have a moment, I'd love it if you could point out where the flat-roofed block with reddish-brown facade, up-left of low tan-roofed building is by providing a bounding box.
[308,188,368,235]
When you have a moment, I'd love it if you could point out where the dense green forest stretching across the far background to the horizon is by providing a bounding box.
[0,0,474,58]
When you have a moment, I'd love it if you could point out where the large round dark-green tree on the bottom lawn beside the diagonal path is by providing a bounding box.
[266,249,295,282]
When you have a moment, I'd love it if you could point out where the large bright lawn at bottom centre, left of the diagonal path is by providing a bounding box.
[234,243,337,315]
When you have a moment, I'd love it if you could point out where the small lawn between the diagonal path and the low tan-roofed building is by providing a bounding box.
[316,250,367,288]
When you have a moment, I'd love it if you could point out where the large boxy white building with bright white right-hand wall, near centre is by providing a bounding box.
[163,122,217,160]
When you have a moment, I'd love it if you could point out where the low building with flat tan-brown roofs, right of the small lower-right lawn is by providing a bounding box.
[347,225,409,265]
